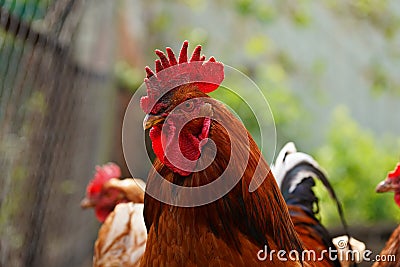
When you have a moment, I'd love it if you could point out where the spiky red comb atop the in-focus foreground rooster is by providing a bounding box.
[140,41,224,113]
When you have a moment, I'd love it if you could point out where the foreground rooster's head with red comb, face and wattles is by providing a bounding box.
[140,41,224,176]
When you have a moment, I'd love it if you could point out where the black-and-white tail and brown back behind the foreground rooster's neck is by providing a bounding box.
[271,142,365,267]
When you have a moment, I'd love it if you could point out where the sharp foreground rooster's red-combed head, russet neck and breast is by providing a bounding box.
[141,41,314,266]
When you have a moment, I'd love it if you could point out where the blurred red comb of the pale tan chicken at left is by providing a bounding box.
[86,162,121,195]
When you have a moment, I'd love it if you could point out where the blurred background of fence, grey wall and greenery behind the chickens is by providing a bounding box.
[0,0,400,266]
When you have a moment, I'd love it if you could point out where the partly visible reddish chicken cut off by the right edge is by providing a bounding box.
[372,163,400,267]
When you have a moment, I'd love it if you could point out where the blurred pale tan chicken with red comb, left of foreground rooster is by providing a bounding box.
[81,163,147,267]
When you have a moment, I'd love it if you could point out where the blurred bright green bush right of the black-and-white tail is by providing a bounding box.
[315,107,400,225]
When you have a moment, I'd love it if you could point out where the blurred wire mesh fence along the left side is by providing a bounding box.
[0,0,115,266]
